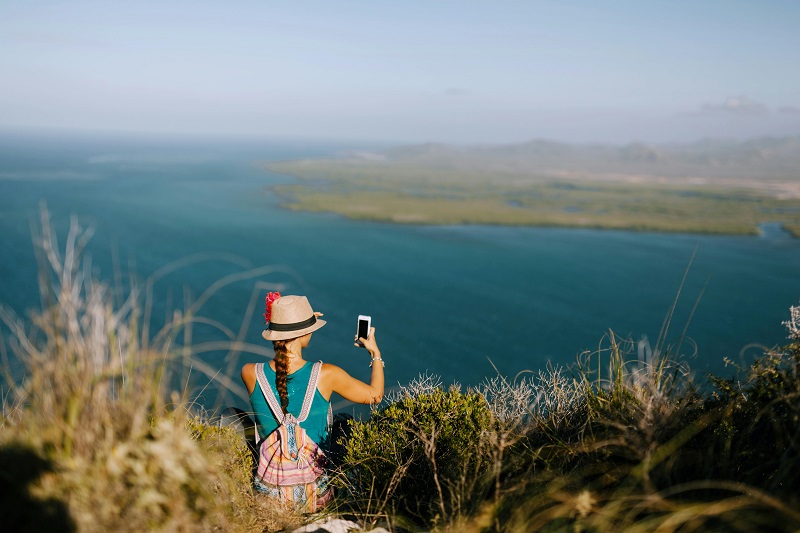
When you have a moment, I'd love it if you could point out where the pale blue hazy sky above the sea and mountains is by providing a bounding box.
[0,0,800,142]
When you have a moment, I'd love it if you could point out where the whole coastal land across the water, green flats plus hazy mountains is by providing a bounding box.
[267,137,800,237]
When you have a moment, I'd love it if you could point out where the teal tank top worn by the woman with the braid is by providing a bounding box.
[250,361,331,450]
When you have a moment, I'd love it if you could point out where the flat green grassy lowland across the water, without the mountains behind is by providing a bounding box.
[269,160,800,236]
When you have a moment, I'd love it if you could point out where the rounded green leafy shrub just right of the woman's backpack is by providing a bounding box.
[345,380,493,523]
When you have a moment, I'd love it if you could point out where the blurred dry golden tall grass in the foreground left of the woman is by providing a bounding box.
[0,210,300,531]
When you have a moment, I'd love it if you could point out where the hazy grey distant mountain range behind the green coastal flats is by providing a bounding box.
[372,137,800,180]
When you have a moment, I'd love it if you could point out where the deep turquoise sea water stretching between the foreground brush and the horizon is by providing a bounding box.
[0,134,800,410]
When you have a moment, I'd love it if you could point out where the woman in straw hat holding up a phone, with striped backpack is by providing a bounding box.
[242,293,384,511]
